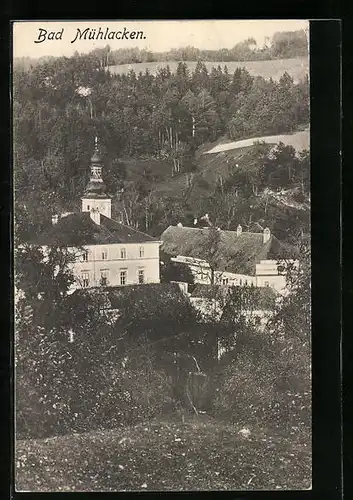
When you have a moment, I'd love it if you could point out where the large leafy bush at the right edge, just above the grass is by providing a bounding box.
[213,334,311,428]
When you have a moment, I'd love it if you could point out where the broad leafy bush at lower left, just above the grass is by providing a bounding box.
[16,332,173,439]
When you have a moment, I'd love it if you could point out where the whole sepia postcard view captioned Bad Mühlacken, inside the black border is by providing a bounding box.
[11,19,312,492]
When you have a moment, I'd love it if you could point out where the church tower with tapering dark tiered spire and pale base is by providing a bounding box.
[81,137,112,219]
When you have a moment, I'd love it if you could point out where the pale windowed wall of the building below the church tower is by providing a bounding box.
[67,242,160,287]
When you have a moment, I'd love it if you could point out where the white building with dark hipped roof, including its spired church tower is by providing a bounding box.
[36,141,161,288]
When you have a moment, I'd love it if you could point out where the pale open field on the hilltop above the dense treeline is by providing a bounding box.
[109,57,309,82]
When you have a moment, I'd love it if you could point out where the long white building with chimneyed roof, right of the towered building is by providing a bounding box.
[161,224,295,293]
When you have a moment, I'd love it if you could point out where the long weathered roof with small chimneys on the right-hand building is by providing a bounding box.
[161,226,296,274]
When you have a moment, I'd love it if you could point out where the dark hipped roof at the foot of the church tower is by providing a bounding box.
[31,212,158,246]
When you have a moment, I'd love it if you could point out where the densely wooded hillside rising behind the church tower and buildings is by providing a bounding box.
[13,47,309,244]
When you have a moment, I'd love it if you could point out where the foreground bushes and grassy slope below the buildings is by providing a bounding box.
[16,237,311,491]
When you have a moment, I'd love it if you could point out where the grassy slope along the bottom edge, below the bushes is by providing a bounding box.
[16,416,311,492]
